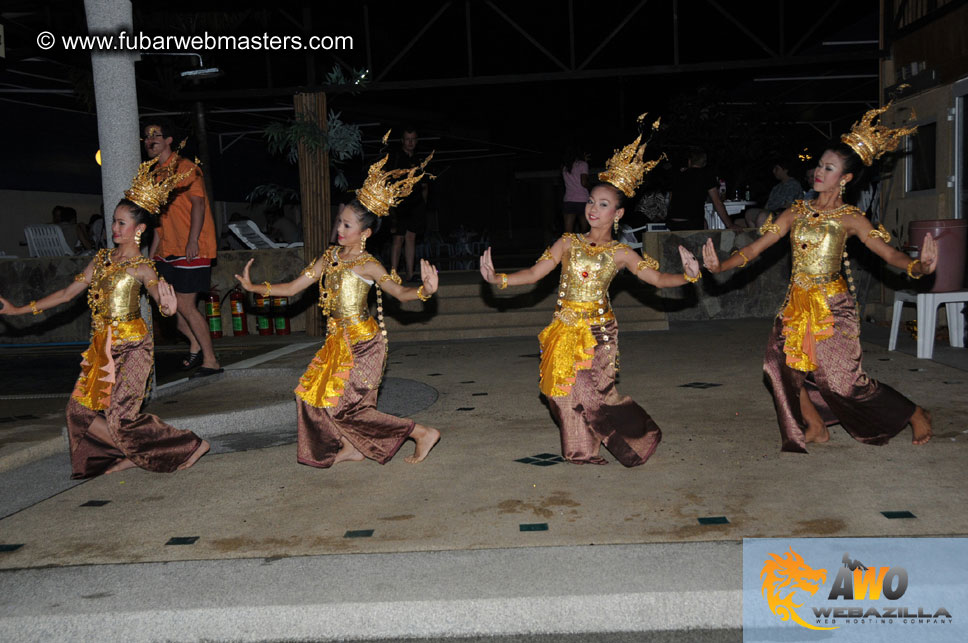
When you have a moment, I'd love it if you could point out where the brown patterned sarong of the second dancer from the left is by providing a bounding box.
[296,333,414,468]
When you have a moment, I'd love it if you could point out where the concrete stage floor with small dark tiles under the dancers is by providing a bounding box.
[0,319,968,641]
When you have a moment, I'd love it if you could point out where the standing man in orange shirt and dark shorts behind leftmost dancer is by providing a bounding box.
[143,119,222,377]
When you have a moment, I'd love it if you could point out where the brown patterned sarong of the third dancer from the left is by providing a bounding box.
[547,320,662,467]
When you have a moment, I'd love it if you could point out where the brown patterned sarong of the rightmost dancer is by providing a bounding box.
[763,293,917,453]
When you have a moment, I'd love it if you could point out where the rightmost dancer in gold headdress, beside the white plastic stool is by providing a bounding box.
[703,104,938,453]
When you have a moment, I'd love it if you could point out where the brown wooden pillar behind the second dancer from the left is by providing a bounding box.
[294,92,331,336]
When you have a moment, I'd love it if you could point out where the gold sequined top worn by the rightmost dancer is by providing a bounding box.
[790,201,863,286]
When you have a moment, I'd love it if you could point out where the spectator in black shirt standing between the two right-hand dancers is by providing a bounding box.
[666,148,741,230]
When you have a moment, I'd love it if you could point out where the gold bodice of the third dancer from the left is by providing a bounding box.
[558,233,628,306]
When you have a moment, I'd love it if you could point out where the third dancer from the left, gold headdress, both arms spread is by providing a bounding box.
[481,114,700,467]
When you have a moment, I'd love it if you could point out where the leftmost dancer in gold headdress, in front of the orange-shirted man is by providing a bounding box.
[0,161,209,478]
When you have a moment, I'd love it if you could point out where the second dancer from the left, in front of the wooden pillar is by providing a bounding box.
[235,147,440,468]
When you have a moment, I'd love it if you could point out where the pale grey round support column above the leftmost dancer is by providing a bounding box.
[84,0,141,246]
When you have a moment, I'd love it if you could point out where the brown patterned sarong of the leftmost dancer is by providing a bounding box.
[67,333,202,479]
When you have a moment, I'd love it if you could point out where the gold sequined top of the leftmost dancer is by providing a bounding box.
[87,248,157,330]
